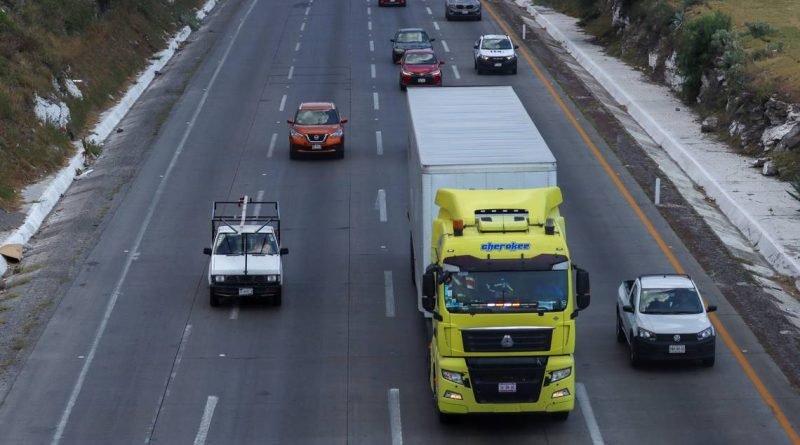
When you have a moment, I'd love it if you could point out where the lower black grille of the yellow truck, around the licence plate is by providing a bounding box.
[467,357,547,403]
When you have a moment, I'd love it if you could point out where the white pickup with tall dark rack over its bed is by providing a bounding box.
[203,196,289,306]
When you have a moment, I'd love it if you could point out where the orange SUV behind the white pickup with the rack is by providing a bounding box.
[286,102,347,159]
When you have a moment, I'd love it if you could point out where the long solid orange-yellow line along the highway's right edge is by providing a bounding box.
[483,1,800,444]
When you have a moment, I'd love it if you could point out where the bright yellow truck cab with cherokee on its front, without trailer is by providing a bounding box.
[421,187,590,420]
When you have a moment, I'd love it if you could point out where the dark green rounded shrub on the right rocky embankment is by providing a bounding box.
[678,11,732,101]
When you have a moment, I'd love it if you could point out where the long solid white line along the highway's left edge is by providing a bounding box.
[51,0,258,445]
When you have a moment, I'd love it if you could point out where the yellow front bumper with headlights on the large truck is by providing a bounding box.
[436,356,575,414]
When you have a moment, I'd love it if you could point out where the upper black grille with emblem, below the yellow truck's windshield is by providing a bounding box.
[461,328,553,352]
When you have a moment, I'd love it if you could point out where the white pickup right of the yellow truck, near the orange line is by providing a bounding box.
[616,274,717,367]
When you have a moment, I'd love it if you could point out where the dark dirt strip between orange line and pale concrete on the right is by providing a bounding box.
[491,0,800,389]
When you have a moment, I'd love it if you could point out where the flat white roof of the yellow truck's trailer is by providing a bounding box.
[408,86,556,171]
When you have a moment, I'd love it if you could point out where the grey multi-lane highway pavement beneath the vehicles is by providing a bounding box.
[0,0,800,445]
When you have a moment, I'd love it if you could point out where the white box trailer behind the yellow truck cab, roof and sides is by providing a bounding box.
[407,86,556,316]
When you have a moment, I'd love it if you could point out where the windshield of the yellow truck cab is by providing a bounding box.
[444,270,569,313]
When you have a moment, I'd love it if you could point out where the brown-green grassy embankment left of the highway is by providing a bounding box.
[0,0,202,210]
